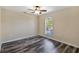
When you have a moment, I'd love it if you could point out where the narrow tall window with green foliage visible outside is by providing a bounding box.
[45,17,53,35]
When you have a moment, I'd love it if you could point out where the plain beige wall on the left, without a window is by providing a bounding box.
[1,9,37,43]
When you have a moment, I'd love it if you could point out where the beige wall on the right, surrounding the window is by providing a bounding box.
[38,7,79,47]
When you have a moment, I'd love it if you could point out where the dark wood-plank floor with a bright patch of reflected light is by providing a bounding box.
[1,36,79,53]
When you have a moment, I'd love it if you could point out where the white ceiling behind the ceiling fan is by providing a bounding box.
[2,6,68,14]
